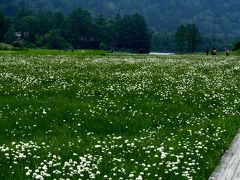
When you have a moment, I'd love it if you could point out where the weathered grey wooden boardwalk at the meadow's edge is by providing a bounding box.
[209,133,240,180]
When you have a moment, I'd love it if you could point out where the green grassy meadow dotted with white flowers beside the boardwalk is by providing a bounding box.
[0,55,240,180]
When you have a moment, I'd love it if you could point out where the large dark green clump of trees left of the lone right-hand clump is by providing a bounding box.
[0,8,151,53]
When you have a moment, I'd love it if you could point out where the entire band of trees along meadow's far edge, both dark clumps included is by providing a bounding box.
[0,6,239,53]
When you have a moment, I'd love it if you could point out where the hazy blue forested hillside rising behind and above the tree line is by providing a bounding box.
[0,0,240,39]
